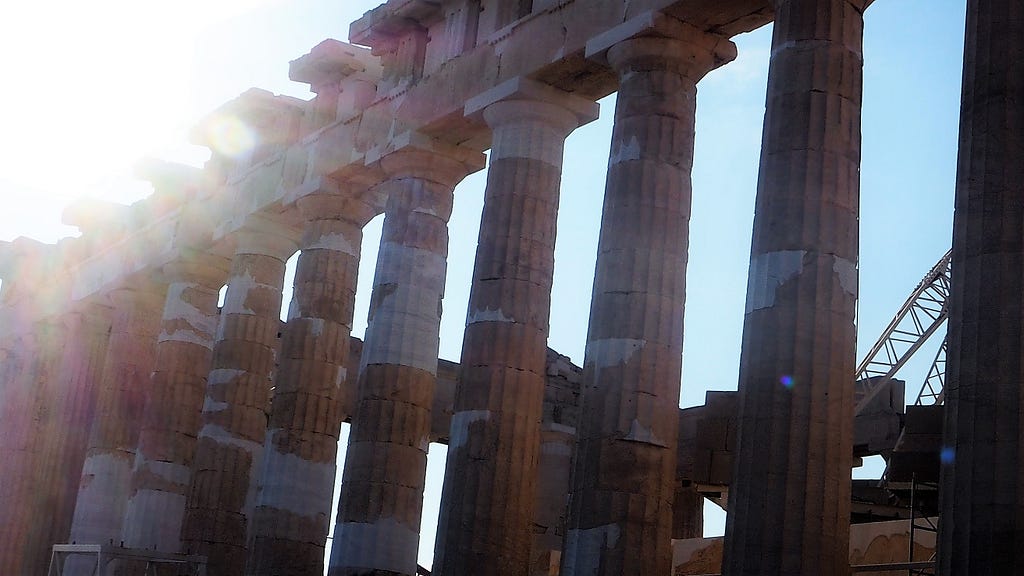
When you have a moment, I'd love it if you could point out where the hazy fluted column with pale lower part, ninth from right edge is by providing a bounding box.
[71,285,166,544]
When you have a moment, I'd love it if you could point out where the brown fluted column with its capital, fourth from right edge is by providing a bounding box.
[434,79,597,576]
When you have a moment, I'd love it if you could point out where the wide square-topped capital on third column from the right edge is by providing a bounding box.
[586,11,736,81]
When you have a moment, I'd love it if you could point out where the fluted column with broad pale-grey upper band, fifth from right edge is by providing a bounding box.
[329,142,483,576]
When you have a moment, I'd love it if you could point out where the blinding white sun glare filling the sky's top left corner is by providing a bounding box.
[0,0,275,240]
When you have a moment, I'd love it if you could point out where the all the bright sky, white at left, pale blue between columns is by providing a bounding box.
[0,0,965,564]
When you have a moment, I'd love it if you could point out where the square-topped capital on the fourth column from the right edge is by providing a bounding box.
[465,76,600,130]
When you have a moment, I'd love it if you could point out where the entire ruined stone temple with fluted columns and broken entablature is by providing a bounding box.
[0,0,1024,576]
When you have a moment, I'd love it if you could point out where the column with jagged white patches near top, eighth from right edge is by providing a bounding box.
[124,253,227,552]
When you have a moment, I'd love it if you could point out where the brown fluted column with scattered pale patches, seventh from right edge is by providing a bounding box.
[179,226,298,574]
